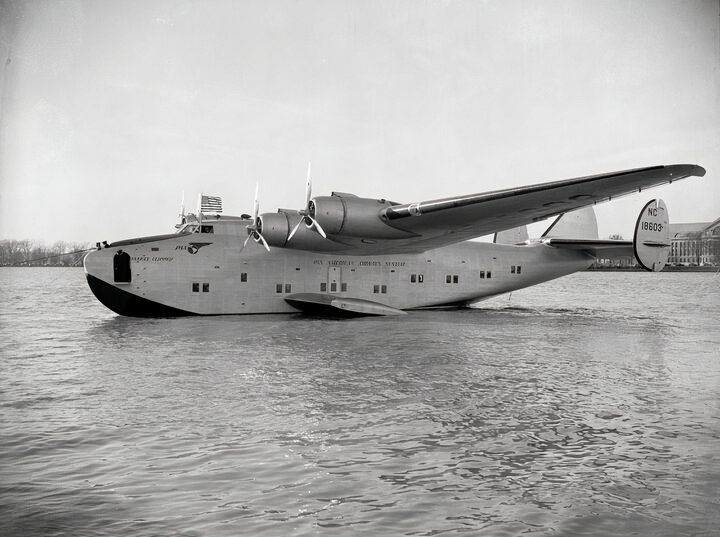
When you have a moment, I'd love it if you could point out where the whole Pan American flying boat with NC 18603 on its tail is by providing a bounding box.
[84,164,705,317]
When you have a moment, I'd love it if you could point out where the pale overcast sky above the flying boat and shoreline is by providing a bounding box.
[0,0,720,243]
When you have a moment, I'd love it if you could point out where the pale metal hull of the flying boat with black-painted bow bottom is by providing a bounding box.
[84,233,593,317]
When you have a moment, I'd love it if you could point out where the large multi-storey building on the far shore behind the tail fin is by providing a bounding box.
[668,218,720,267]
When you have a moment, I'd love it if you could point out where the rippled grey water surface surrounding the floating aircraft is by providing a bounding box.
[0,269,720,536]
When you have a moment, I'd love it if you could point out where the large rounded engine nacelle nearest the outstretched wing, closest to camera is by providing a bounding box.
[310,193,413,240]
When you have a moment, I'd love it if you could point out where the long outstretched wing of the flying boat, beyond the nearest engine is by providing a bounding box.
[368,164,705,252]
